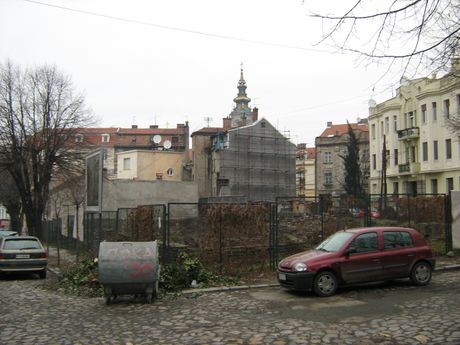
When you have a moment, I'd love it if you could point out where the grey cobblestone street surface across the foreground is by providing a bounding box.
[0,270,460,345]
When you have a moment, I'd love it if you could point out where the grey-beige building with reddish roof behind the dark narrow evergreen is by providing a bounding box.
[315,120,369,196]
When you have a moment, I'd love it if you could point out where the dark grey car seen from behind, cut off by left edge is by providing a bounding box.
[0,236,48,279]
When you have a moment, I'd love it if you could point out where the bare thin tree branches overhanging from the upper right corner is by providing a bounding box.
[313,0,460,74]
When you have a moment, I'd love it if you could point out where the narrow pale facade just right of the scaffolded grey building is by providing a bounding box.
[295,144,316,197]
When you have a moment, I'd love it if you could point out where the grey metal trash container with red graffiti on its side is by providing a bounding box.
[98,241,160,304]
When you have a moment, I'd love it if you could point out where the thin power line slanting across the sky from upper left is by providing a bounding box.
[22,0,335,54]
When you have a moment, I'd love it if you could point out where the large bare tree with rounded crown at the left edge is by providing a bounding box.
[0,62,92,234]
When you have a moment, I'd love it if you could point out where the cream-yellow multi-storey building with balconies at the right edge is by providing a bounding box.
[369,60,460,194]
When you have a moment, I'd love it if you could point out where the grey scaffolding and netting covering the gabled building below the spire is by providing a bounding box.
[213,122,296,201]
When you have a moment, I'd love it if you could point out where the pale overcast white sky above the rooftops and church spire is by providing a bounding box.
[0,0,410,146]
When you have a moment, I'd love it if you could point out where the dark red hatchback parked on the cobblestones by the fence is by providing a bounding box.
[277,227,436,297]
